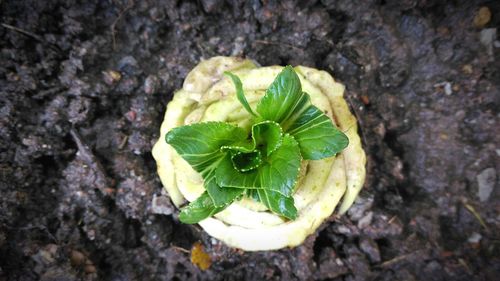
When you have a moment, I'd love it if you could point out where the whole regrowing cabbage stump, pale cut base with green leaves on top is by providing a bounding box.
[153,57,366,250]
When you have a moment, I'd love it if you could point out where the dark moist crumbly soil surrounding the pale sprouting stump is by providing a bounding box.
[0,0,500,281]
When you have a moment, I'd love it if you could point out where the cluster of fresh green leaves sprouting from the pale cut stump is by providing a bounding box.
[165,66,349,223]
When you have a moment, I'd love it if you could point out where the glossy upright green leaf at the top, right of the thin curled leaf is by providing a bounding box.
[256,66,308,123]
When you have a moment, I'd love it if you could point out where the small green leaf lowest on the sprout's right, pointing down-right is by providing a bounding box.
[257,189,297,220]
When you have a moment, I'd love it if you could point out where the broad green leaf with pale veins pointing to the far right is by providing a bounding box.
[287,105,349,160]
